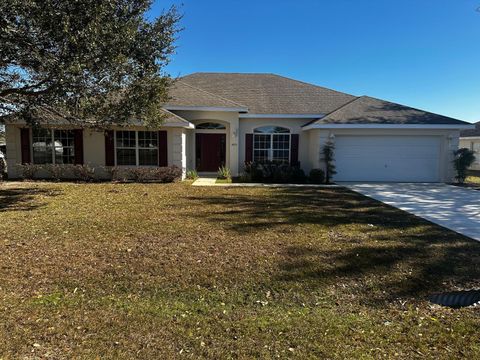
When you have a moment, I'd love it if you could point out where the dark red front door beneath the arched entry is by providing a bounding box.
[195,134,226,172]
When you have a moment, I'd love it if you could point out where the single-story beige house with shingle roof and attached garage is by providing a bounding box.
[2,73,472,182]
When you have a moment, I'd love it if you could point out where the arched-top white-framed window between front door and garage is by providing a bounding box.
[253,126,290,163]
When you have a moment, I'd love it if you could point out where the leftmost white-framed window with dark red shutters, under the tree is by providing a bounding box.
[32,128,75,164]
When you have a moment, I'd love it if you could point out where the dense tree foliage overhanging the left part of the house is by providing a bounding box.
[0,0,180,125]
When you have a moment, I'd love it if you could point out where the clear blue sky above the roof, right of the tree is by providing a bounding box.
[151,0,480,122]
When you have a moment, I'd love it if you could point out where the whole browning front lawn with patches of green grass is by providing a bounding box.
[0,182,480,359]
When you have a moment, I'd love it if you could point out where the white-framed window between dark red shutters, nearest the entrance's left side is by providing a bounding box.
[115,130,158,166]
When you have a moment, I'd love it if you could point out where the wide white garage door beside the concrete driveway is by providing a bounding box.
[335,136,441,182]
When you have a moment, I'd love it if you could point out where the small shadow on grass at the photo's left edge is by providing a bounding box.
[0,187,59,212]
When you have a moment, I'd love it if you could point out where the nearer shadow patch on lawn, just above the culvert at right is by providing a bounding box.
[276,234,480,306]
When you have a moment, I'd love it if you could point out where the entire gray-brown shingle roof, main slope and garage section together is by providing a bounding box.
[166,73,468,125]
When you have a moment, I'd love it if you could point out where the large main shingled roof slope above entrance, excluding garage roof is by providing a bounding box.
[173,73,355,114]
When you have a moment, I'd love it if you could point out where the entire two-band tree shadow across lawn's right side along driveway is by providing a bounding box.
[186,189,480,306]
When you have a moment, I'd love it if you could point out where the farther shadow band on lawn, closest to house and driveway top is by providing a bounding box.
[188,188,427,234]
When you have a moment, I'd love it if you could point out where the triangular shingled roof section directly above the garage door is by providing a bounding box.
[306,96,467,125]
